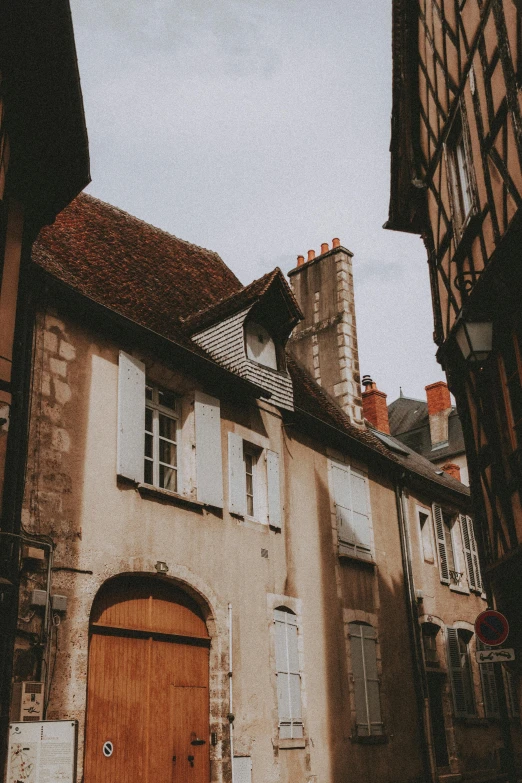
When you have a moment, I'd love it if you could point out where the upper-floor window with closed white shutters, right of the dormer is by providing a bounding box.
[332,462,373,561]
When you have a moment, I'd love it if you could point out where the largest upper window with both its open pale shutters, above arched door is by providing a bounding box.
[117,351,223,508]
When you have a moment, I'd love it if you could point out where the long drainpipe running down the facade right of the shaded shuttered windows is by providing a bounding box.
[395,474,436,783]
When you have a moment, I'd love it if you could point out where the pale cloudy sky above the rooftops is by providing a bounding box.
[71,0,444,402]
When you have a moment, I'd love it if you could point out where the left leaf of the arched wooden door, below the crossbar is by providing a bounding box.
[85,634,151,783]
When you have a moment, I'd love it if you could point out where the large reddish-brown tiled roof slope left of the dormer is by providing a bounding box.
[33,194,243,350]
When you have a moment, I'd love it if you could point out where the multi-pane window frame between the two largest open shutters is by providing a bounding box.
[143,380,182,495]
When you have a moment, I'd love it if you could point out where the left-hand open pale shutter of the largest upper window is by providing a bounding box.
[117,351,145,483]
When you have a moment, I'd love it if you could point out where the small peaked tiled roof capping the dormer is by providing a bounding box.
[183,267,303,334]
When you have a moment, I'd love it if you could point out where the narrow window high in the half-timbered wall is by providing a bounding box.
[445,112,475,234]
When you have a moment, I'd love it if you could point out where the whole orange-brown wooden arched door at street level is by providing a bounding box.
[84,577,210,783]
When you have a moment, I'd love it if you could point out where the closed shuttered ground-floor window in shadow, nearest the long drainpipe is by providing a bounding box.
[348,623,383,737]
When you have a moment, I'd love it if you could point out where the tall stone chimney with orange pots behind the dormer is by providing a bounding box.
[289,238,363,427]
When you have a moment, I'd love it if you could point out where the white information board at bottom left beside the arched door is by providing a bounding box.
[6,720,78,783]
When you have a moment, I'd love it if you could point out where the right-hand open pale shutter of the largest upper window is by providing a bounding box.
[194,391,223,508]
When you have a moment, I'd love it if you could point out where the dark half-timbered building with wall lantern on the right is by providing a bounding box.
[387,0,522,728]
